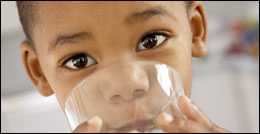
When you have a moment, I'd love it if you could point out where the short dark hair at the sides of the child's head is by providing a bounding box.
[16,1,192,43]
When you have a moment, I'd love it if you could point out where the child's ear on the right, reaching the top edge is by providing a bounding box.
[188,1,208,57]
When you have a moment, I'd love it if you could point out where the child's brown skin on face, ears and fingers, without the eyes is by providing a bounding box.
[21,2,228,132]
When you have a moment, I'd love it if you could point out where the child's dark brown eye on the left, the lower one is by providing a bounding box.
[64,54,97,70]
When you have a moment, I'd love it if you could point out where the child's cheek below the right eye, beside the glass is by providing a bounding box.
[144,33,192,96]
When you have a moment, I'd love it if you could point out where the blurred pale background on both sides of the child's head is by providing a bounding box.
[1,1,259,132]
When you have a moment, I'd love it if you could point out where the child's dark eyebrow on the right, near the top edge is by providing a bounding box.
[125,6,176,25]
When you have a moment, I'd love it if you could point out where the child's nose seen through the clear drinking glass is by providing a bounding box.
[99,65,149,103]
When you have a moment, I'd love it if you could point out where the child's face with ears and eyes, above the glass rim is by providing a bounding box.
[22,2,206,107]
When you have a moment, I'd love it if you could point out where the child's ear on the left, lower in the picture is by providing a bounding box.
[20,41,53,96]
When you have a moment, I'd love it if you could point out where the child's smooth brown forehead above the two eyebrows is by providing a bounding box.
[33,1,186,48]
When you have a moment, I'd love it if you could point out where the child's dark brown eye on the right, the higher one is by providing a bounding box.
[136,33,167,51]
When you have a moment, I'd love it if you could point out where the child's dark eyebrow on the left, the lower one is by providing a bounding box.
[49,32,91,51]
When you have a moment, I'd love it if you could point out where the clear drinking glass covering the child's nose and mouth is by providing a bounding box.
[65,62,184,132]
